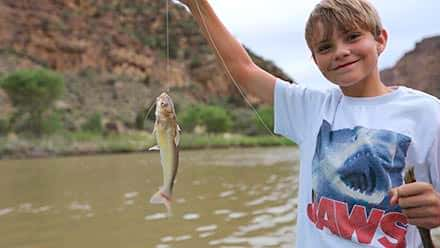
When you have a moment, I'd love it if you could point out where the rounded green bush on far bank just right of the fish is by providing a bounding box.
[180,105,232,133]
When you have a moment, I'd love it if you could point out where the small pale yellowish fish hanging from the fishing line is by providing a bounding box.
[149,92,181,216]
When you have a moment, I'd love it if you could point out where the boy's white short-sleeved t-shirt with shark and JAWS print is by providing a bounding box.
[274,80,440,248]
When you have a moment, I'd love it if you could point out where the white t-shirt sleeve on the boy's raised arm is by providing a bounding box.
[274,79,325,144]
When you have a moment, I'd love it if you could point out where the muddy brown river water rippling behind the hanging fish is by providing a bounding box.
[0,147,440,248]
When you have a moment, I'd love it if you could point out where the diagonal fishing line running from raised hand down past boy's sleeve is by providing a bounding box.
[194,0,276,136]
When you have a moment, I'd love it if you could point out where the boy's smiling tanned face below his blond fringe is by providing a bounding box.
[312,22,387,89]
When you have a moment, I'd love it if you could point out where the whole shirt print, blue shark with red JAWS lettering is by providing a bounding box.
[307,121,411,248]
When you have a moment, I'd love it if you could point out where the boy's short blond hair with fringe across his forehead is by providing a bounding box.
[305,0,382,50]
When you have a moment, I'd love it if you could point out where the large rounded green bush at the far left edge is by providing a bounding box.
[0,69,64,135]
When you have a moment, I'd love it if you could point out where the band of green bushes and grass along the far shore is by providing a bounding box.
[0,68,293,159]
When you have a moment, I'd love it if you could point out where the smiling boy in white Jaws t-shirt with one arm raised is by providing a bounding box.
[178,0,440,248]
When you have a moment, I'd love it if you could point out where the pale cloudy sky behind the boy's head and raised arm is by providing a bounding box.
[194,0,440,89]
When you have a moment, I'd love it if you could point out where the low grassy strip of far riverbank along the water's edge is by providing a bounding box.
[0,131,294,159]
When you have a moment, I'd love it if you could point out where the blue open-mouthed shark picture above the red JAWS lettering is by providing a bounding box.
[312,120,411,213]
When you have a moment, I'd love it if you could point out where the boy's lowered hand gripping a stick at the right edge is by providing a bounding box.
[390,182,440,229]
